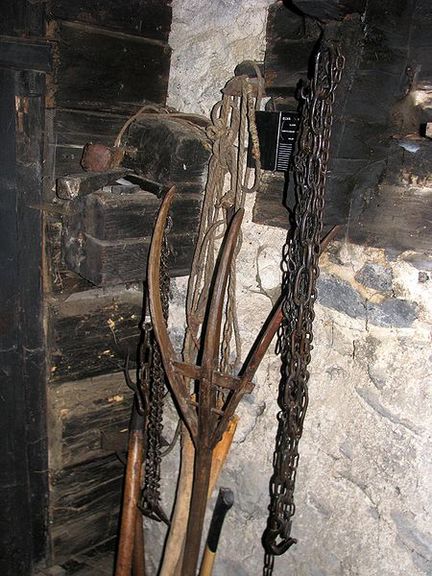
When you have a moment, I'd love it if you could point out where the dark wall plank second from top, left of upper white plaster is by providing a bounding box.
[48,21,171,114]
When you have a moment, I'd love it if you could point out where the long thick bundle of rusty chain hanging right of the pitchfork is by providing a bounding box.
[263,40,344,576]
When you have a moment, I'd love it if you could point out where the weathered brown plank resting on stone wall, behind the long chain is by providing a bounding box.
[254,154,432,252]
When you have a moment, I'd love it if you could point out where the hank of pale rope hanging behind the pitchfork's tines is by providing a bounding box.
[183,69,263,373]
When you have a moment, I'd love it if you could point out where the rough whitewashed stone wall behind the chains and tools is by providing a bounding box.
[148,0,432,576]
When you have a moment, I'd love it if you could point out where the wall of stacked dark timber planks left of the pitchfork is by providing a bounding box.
[43,0,171,566]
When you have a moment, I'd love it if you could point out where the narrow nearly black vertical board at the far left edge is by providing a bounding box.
[0,70,32,576]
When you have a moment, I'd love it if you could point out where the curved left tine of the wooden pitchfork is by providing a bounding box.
[147,187,198,438]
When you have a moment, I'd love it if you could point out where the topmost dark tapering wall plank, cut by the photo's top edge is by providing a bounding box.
[47,0,172,41]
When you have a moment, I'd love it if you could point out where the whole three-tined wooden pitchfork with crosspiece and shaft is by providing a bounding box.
[148,188,336,576]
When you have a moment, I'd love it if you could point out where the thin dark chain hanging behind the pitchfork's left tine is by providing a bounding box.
[140,215,171,524]
